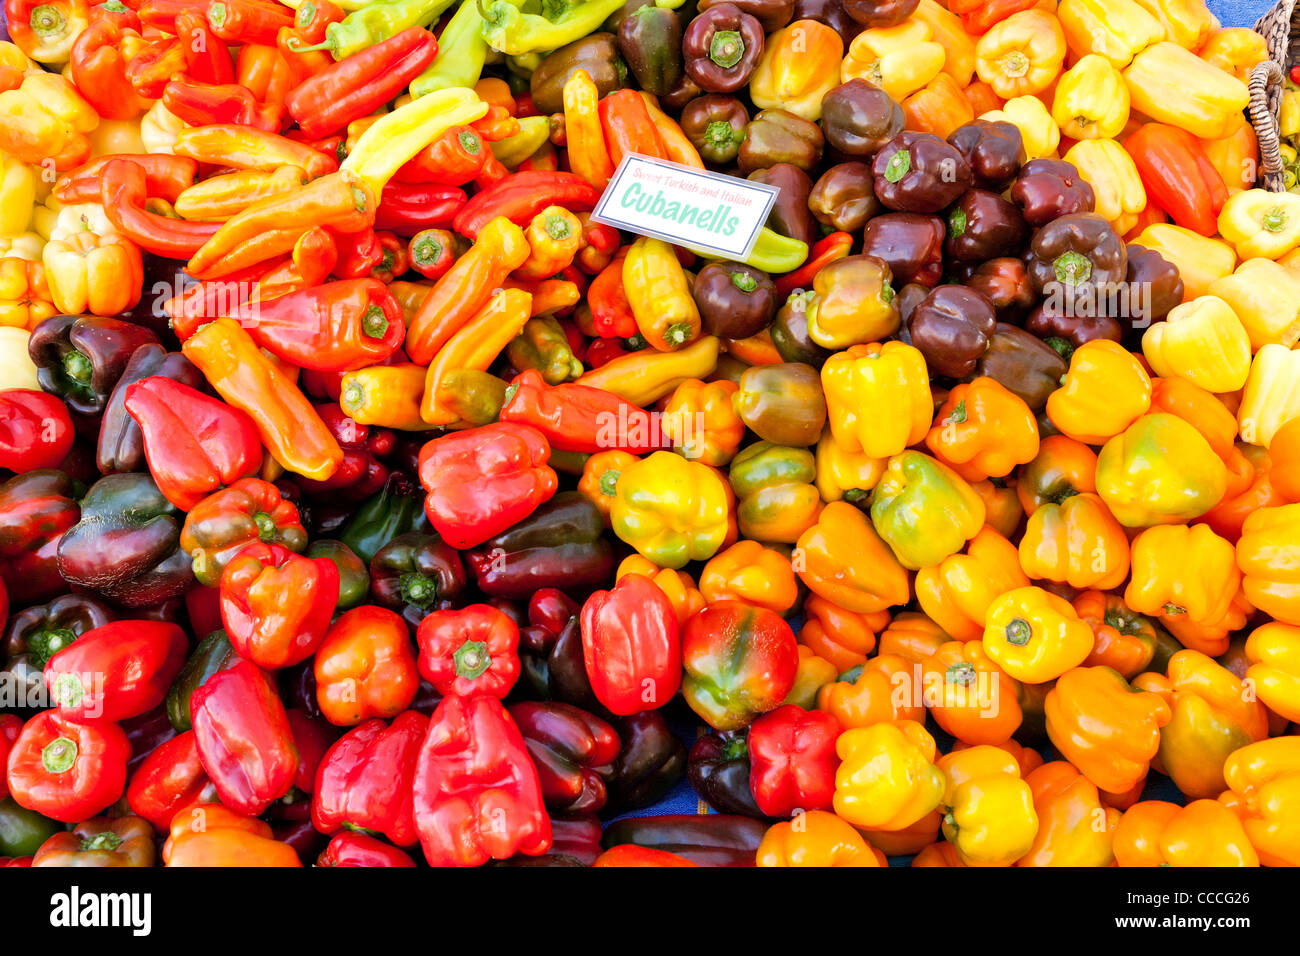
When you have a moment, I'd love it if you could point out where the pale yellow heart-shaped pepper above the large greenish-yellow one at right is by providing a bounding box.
[1141,295,1251,393]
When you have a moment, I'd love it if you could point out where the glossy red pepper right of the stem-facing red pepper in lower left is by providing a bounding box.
[190,661,298,817]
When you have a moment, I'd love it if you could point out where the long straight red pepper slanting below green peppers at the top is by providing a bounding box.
[285,26,438,137]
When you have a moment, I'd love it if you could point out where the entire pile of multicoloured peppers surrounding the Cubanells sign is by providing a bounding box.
[0,0,1300,866]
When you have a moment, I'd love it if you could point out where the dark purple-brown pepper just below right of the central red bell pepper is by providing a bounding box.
[463,492,614,598]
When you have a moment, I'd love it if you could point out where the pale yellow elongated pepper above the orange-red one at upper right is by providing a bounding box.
[1123,41,1251,139]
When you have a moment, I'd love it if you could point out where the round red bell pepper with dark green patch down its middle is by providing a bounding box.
[681,601,798,731]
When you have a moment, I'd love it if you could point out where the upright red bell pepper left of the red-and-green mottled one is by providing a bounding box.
[581,574,681,717]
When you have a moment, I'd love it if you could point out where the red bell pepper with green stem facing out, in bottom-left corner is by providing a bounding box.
[8,710,131,823]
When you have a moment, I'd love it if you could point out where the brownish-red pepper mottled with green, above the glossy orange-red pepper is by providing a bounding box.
[181,477,307,584]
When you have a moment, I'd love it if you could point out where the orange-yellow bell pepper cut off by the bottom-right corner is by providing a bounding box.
[1219,736,1300,866]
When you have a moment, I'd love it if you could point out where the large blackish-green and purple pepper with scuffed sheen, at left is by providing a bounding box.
[59,473,194,607]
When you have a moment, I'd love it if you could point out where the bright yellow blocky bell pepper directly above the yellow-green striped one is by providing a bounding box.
[822,342,935,458]
